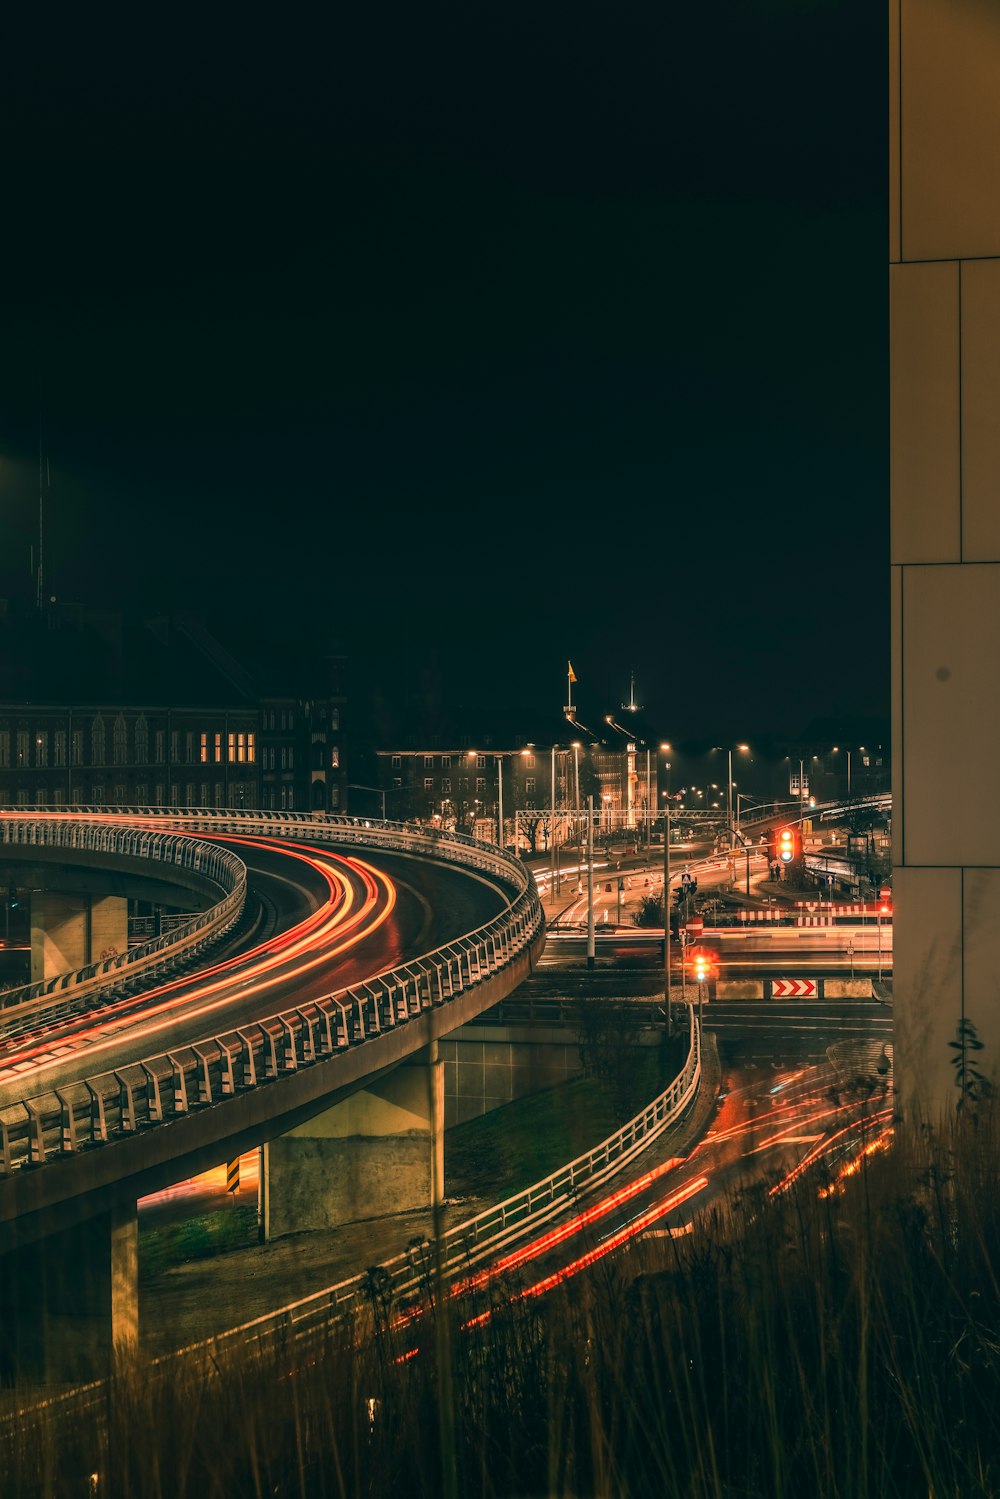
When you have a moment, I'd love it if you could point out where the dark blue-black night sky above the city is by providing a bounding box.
[0,0,889,738]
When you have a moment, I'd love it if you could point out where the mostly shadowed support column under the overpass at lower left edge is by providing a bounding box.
[0,1202,139,1384]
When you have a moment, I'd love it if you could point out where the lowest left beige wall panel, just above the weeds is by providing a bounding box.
[892,868,963,1121]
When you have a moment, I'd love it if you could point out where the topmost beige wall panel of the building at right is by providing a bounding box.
[900,0,1000,261]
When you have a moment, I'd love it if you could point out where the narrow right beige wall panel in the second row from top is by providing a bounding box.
[961,257,1000,562]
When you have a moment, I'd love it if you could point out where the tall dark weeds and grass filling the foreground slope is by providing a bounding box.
[0,1103,1000,1499]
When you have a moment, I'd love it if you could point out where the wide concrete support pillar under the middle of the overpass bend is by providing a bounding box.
[259,1051,444,1240]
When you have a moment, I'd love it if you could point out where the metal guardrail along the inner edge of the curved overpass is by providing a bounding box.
[0,815,246,1036]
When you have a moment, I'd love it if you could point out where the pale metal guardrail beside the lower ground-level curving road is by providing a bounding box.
[153,1006,702,1364]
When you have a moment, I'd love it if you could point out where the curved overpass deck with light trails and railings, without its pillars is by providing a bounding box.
[0,809,544,1252]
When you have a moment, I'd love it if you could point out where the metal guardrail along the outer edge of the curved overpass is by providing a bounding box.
[0,808,544,1178]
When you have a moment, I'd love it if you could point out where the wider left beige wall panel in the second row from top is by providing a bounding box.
[889,264,961,562]
